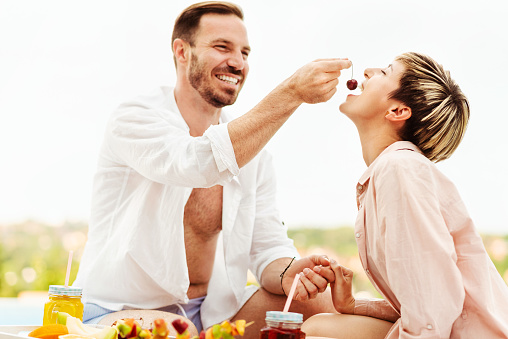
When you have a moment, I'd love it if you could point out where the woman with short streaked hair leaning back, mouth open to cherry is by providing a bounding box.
[303,53,508,339]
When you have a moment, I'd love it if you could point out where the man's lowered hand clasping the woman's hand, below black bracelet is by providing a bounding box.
[282,255,335,301]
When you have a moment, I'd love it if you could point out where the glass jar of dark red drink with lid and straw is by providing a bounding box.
[260,311,305,339]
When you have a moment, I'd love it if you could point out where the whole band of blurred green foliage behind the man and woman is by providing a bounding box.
[0,221,508,297]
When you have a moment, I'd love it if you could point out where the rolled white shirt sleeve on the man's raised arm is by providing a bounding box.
[106,98,239,187]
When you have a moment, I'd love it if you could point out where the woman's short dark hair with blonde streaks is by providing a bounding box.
[390,53,469,162]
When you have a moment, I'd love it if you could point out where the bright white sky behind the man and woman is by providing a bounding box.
[0,0,508,234]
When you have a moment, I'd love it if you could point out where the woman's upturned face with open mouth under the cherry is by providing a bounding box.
[339,61,404,122]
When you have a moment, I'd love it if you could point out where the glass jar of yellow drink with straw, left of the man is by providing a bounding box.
[42,285,83,325]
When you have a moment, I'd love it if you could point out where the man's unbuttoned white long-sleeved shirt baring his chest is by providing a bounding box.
[74,87,299,328]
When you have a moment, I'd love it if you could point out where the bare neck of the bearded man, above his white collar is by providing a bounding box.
[175,85,221,137]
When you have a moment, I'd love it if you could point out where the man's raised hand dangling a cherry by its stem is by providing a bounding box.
[283,59,351,104]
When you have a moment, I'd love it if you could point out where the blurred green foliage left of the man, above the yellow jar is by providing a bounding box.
[0,221,88,297]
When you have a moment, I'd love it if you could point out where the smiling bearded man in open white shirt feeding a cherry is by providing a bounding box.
[74,2,350,338]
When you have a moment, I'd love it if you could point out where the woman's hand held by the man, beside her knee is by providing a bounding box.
[330,259,355,314]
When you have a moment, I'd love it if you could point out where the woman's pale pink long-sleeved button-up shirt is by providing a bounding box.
[355,141,508,339]
